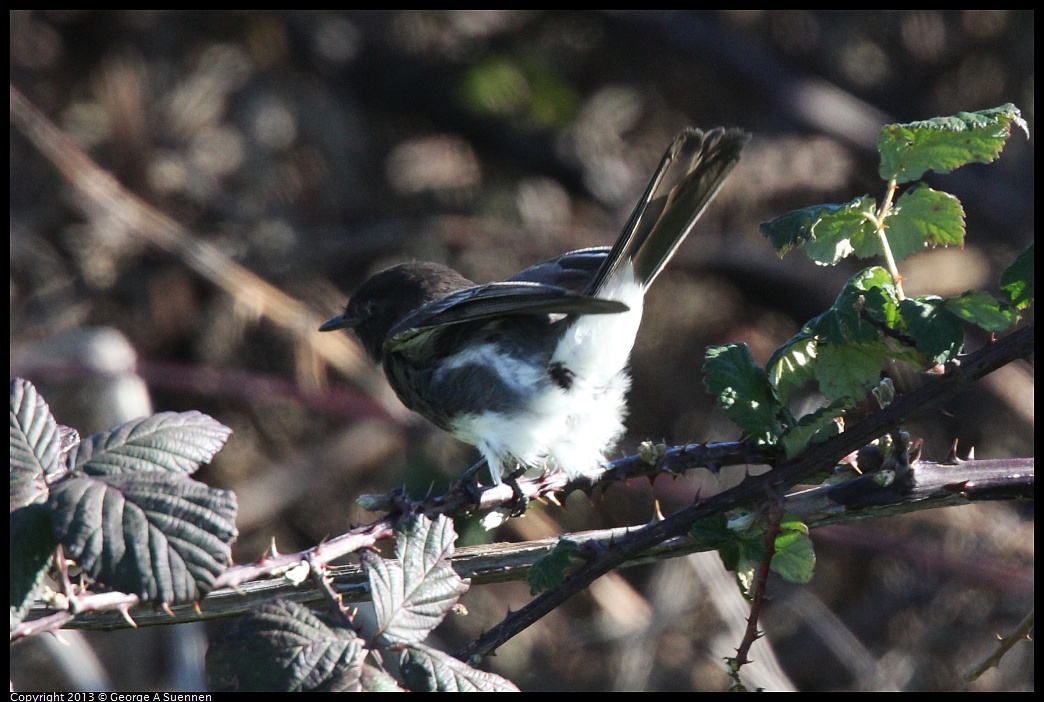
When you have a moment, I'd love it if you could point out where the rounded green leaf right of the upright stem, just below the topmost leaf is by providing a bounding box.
[876,185,965,261]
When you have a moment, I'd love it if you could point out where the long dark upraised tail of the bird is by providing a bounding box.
[588,127,751,295]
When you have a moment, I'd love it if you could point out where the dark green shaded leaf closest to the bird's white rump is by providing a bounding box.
[704,344,785,443]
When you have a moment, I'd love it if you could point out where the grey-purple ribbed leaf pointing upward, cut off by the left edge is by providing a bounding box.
[10,378,62,510]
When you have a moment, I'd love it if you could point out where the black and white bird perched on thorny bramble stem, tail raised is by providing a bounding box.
[319,127,750,484]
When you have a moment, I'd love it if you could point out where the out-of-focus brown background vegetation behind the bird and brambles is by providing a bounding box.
[10,10,1035,691]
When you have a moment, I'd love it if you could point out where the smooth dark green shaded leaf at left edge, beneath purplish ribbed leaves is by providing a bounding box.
[9,505,58,629]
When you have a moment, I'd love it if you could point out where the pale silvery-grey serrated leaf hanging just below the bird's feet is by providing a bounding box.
[362,515,469,646]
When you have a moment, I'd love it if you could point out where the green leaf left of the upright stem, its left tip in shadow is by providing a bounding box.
[761,195,877,265]
